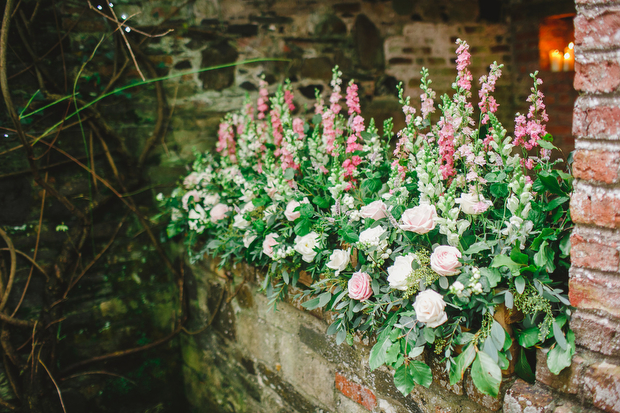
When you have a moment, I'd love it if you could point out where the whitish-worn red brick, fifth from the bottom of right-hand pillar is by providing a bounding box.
[570,188,620,228]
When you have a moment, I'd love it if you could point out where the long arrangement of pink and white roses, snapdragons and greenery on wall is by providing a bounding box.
[160,40,575,396]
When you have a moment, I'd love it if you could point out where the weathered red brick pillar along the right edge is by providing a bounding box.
[568,0,620,412]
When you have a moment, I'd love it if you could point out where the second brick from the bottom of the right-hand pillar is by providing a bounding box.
[570,310,620,356]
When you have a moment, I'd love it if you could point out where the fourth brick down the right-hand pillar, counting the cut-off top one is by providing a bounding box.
[573,106,620,139]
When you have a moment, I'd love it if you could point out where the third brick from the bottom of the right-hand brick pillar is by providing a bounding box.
[568,266,620,317]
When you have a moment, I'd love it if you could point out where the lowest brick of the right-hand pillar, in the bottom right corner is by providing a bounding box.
[582,361,620,413]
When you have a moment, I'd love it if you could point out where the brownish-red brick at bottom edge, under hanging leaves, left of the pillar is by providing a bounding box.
[504,379,555,413]
